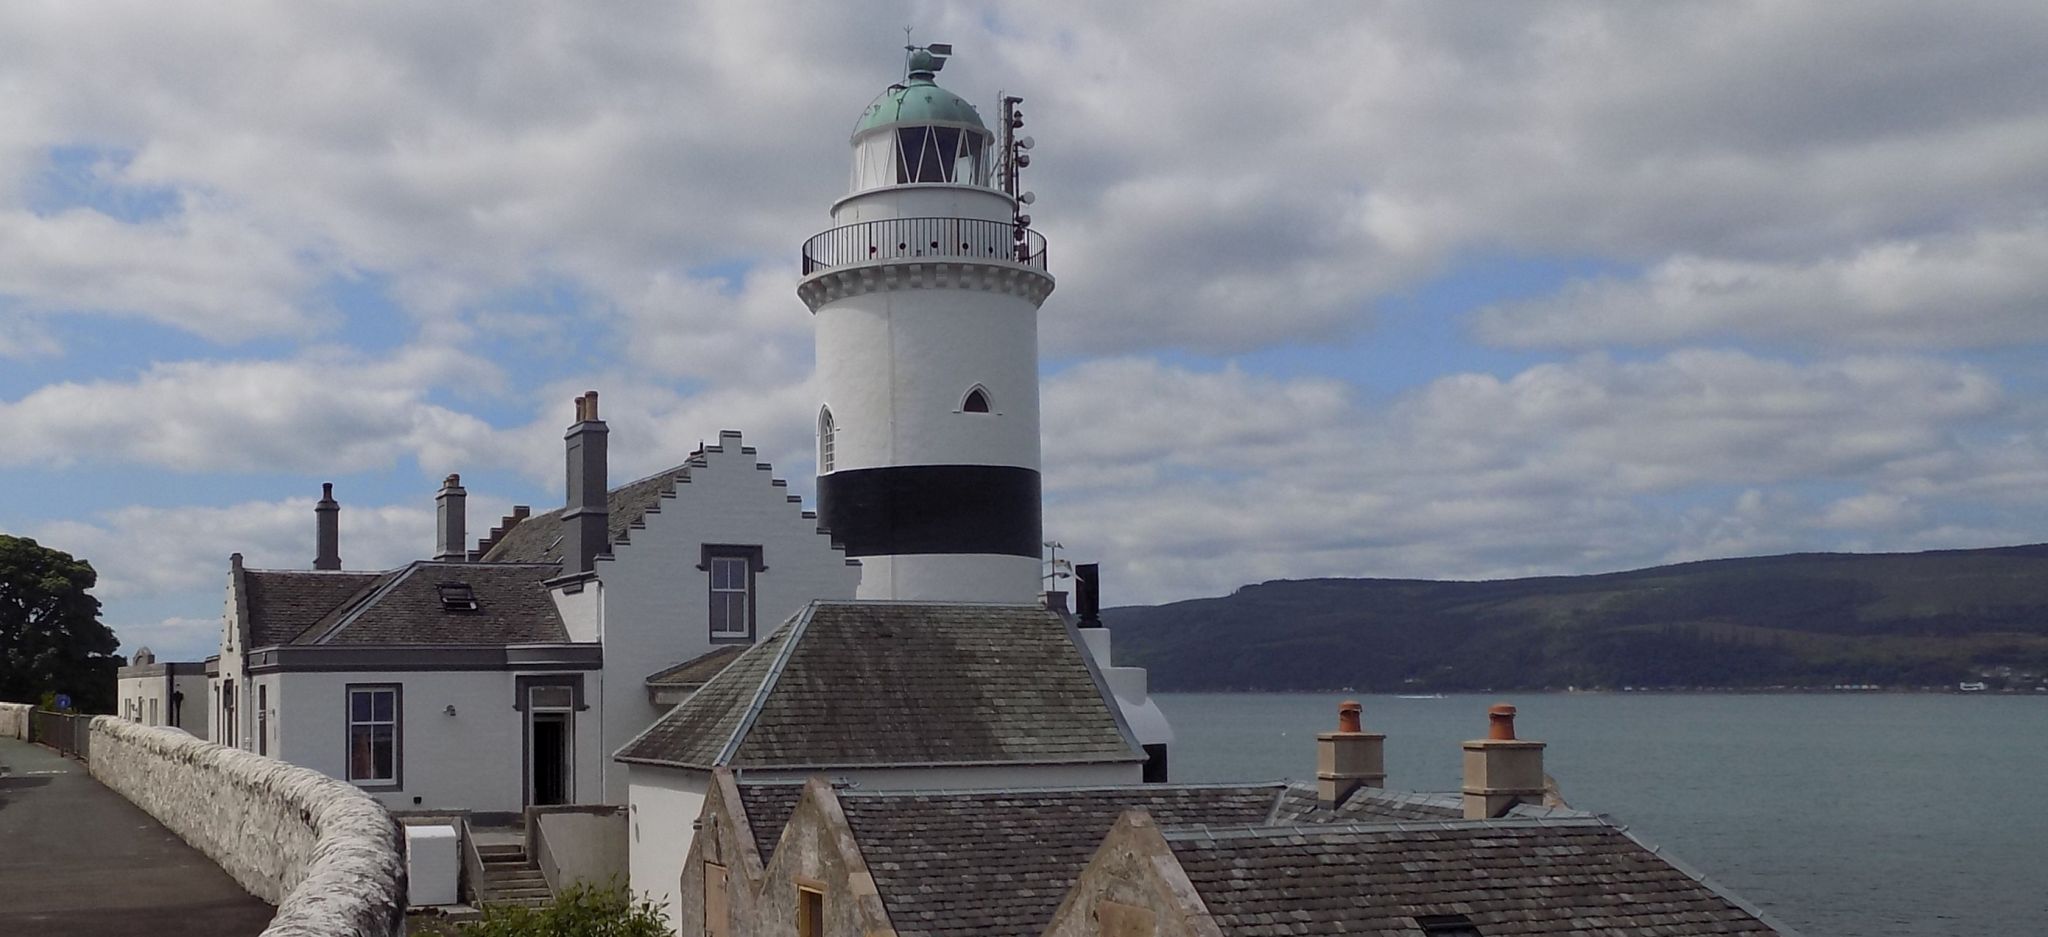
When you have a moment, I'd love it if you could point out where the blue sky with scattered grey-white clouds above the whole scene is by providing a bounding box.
[0,0,2048,659]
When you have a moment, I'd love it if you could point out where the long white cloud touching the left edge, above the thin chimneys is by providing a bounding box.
[0,348,502,473]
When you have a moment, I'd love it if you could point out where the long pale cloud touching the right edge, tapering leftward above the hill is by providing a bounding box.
[1477,225,2048,348]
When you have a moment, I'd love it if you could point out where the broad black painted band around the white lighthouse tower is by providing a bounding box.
[817,464,1042,556]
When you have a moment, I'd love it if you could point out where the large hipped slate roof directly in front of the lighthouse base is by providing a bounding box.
[616,601,1145,769]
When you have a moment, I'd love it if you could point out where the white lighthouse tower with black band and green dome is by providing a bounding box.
[797,45,1053,604]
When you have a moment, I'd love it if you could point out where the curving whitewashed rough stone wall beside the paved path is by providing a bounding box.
[90,716,406,937]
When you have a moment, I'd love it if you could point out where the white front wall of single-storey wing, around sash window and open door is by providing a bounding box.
[258,671,608,812]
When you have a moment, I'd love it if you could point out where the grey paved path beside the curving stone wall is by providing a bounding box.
[0,739,274,937]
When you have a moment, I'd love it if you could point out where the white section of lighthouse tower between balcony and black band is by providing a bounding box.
[813,288,1038,476]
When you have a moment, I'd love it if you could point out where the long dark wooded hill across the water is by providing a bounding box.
[1102,544,2048,691]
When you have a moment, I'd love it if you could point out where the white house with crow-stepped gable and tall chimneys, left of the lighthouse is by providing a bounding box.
[211,413,860,812]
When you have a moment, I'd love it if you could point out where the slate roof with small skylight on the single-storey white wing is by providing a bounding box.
[293,561,569,646]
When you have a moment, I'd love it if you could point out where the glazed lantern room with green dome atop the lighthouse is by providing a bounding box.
[852,45,995,192]
